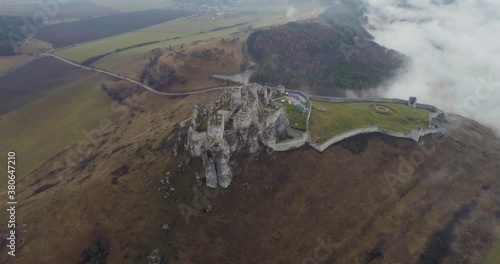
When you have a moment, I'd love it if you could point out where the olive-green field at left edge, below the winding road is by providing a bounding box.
[0,75,122,191]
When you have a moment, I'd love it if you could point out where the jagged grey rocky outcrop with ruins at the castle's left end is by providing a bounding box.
[185,84,290,188]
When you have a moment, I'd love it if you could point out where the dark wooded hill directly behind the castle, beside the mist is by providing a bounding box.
[247,21,406,95]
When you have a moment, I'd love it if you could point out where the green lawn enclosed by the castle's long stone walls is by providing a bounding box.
[310,101,431,142]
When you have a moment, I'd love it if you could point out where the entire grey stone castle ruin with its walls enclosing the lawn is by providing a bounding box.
[182,84,446,188]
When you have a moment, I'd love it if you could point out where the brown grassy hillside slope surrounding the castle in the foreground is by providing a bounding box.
[0,87,500,263]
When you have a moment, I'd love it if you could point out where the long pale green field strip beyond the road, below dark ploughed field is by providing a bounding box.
[56,5,298,70]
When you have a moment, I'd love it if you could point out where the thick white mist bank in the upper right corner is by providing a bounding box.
[367,0,500,133]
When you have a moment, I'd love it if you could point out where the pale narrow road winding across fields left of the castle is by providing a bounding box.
[40,53,240,96]
